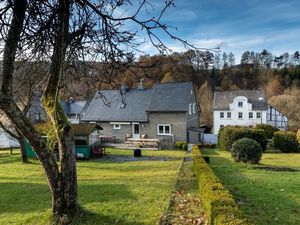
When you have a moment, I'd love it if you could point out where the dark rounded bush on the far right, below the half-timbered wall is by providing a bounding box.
[273,131,299,153]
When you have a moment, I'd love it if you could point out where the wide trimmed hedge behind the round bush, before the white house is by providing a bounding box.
[218,126,268,151]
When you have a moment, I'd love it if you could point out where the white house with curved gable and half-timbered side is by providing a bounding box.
[213,90,288,134]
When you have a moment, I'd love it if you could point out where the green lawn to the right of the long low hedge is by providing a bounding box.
[203,149,300,225]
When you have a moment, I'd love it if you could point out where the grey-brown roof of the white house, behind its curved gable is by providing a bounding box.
[213,90,268,110]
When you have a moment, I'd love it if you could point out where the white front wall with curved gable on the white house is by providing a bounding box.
[214,96,267,134]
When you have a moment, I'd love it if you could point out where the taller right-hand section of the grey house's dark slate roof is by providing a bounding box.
[147,82,195,112]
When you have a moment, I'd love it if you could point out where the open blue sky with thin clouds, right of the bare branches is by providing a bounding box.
[131,0,300,63]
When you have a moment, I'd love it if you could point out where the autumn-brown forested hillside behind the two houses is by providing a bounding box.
[62,50,300,129]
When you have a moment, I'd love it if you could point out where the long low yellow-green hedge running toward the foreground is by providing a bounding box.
[193,145,250,225]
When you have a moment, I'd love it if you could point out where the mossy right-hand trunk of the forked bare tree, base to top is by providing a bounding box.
[43,0,77,223]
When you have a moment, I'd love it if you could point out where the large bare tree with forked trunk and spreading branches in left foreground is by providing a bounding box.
[0,0,198,224]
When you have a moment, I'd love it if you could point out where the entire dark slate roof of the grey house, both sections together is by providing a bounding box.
[82,82,195,122]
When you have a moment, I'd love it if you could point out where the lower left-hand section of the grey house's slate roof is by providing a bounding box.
[82,89,152,122]
